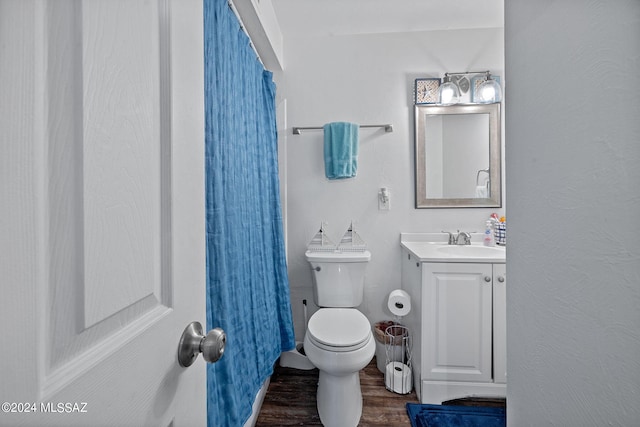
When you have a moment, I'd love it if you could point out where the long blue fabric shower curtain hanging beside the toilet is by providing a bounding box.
[204,0,295,427]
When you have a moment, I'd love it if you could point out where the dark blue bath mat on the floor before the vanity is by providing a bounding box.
[407,403,507,427]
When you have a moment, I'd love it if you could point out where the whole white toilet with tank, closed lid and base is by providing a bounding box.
[304,251,376,427]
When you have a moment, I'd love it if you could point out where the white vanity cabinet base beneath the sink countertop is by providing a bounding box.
[402,248,506,404]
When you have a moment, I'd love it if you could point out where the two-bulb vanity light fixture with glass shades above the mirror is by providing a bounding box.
[438,71,502,105]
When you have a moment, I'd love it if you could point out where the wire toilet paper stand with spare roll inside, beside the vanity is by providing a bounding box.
[384,325,413,394]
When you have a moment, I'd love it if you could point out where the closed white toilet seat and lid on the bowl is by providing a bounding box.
[307,308,372,352]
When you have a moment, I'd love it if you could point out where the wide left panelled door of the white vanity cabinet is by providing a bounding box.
[422,263,492,382]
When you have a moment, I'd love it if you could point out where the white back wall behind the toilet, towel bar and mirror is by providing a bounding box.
[275,28,504,339]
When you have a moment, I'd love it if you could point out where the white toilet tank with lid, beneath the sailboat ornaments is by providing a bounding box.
[305,251,371,307]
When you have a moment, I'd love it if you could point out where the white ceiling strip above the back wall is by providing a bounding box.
[268,0,505,39]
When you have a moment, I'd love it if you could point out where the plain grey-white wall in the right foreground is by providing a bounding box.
[505,0,640,427]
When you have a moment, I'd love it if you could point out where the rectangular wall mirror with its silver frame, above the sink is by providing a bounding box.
[415,103,502,208]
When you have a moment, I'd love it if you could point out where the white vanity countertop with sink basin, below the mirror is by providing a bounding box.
[400,233,507,264]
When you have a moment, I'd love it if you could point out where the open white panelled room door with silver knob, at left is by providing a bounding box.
[0,0,206,426]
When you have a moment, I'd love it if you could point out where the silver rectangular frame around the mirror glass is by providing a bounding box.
[414,102,502,209]
